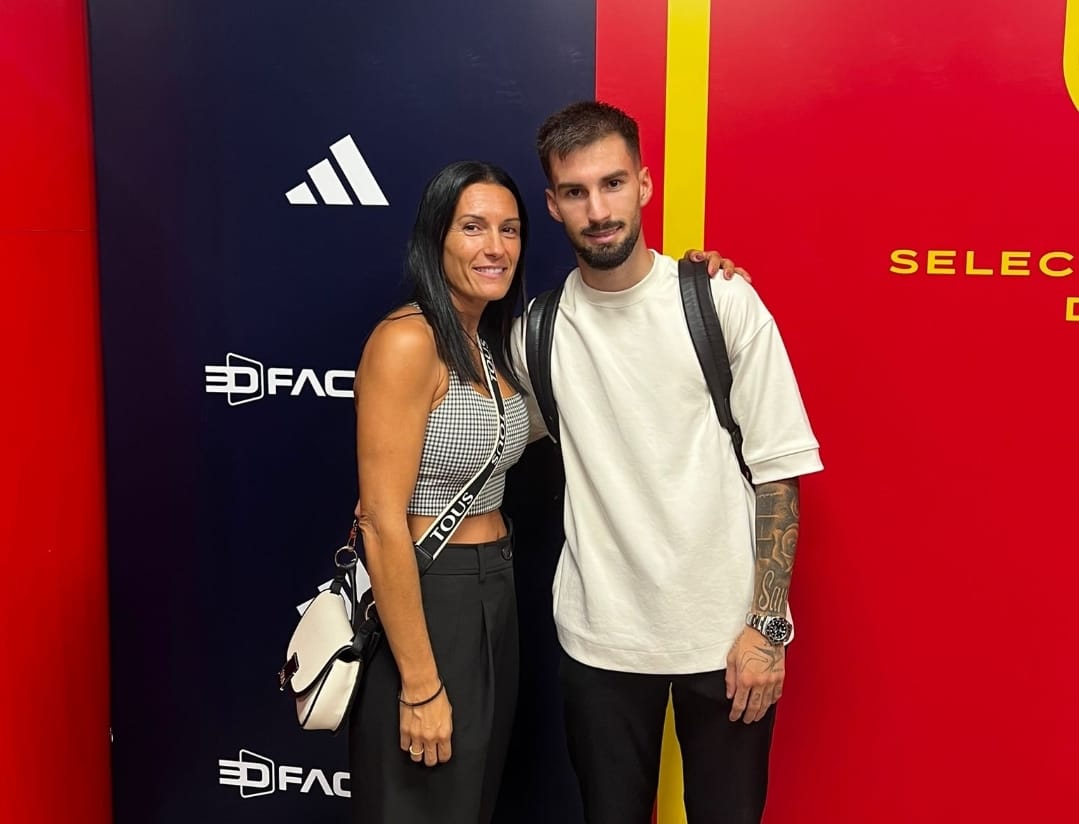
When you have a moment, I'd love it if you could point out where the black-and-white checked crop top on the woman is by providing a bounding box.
[408,369,529,516]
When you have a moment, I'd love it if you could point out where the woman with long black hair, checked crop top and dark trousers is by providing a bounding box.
[350,162,529,824]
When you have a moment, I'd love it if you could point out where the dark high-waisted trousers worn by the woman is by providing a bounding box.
[349,537,518,824]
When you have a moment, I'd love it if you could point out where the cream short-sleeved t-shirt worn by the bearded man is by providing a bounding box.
[513,253,822,674]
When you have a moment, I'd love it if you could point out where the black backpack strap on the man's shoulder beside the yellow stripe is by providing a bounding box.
[678,260,753,483]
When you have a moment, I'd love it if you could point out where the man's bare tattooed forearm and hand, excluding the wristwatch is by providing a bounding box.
[726,478,798,724]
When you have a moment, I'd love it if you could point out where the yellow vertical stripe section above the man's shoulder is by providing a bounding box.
[664,0,710,255]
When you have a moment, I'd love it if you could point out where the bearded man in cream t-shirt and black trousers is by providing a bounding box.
[514,101,821,824]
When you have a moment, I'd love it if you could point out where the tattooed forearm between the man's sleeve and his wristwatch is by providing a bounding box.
[753,479,798,615]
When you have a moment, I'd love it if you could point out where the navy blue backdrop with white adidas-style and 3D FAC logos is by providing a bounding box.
[88,0,595,824]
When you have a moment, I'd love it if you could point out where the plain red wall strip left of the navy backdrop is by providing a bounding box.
[0,0,111,824]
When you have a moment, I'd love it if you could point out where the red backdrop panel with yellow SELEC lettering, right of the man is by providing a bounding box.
[706,0,1079,824]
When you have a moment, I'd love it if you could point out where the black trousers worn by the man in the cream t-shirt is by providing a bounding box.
[560,653,776,824]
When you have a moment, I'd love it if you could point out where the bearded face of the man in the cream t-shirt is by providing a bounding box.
[547,135,652,270]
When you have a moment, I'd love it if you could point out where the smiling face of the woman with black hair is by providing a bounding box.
[442,183,521,312]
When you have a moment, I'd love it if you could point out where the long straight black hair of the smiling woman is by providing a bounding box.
[405,161,529,392]
